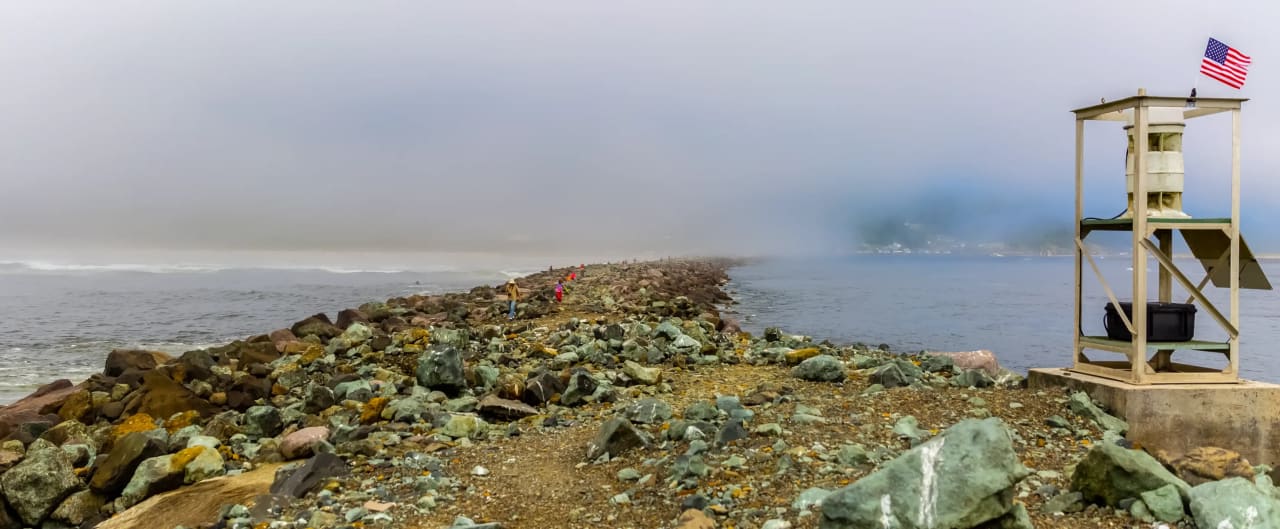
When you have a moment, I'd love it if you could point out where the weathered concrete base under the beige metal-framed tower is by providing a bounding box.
[1027,369,1280,468]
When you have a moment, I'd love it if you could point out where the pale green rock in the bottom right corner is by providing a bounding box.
[1190,478,1280,529]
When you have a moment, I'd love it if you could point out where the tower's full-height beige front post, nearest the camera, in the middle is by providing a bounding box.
[1131,104,1151,384]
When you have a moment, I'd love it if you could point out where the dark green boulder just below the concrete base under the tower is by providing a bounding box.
[1071,443,1190,507]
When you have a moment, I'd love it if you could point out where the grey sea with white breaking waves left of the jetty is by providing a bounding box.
[0,263,522,403]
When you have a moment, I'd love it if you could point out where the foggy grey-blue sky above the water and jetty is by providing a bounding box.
[0,0,1280,262]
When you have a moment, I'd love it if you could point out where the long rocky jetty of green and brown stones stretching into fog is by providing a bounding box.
[0,260,1264,529]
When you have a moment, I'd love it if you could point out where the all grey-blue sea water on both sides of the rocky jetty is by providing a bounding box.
[0,255,1280,403]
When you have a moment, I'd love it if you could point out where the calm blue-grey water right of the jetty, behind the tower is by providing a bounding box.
[728,255,1280,382]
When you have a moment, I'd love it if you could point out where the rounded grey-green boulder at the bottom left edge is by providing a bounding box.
[0,441,81,525]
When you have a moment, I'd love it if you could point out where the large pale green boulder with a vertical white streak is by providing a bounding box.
[819,419,1030,529]
